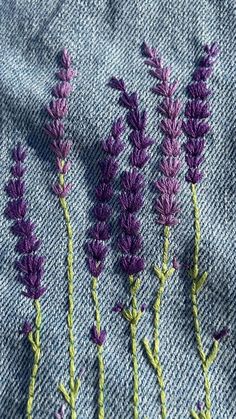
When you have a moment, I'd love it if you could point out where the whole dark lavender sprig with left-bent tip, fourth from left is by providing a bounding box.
[109,78,153,419]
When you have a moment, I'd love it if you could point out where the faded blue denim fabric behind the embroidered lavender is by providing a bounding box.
[0,0,236,419]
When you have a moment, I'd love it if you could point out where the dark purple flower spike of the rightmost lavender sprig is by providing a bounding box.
[182,43,219,184]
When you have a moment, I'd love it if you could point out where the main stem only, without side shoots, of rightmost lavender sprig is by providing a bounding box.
[191,184,211,419]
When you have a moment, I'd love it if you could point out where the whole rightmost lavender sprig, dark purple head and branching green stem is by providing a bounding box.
[183,43,225,419]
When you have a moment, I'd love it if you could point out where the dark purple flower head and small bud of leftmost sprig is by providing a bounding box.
[5,144,46,300]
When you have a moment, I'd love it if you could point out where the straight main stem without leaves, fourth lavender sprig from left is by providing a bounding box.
[130,277,139,419]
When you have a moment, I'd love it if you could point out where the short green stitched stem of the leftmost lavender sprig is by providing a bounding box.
[26,300,42,419]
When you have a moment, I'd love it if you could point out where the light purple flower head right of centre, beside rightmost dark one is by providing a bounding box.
[143,43,182,226]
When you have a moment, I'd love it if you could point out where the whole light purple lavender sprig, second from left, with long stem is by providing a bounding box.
[45,49,81,419]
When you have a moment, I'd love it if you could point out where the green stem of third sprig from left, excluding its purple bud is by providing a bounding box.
[92,278,105,419]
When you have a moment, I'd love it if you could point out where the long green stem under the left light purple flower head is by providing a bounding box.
[58,170,81,419]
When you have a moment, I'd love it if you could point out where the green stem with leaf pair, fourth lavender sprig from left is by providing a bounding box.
[121,275,143,419]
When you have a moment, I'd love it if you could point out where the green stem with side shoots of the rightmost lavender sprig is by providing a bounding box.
[189,184,219,419]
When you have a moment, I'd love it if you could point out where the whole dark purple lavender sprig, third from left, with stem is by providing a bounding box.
[87,118,124,419]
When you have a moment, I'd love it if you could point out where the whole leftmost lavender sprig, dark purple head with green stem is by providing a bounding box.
[5,143,46,419]
